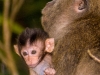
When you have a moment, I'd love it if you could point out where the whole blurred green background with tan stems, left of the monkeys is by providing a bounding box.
[0,0,50,75]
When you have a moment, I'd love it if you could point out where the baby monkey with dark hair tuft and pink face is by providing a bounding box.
[14,28,56,75]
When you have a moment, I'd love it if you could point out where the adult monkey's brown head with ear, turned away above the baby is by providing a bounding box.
[42,0,100,40]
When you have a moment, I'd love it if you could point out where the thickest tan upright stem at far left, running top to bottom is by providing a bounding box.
[1,0,18,75]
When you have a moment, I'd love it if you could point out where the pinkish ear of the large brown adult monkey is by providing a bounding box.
[75,0,87,11]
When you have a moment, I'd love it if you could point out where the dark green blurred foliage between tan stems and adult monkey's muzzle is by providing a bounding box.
[16,0,50,28]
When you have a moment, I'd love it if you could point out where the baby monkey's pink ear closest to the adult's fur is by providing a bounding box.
[45,38,54,53]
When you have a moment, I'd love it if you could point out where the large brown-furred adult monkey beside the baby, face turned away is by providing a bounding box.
[42,0,100,75]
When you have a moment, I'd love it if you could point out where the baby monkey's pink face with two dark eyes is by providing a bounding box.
[21,41,44,67]
